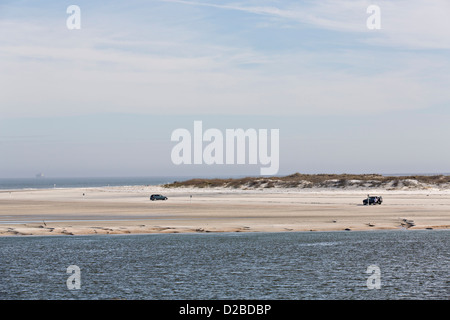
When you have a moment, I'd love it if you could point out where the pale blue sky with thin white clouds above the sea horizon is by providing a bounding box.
[0,0,450,178]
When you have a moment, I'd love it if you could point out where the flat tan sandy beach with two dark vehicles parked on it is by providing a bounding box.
[0,186,450,236]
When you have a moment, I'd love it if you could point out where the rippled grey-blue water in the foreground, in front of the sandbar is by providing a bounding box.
[0,230,450,300]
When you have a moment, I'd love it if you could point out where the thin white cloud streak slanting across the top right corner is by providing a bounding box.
[160,0,450,49]
